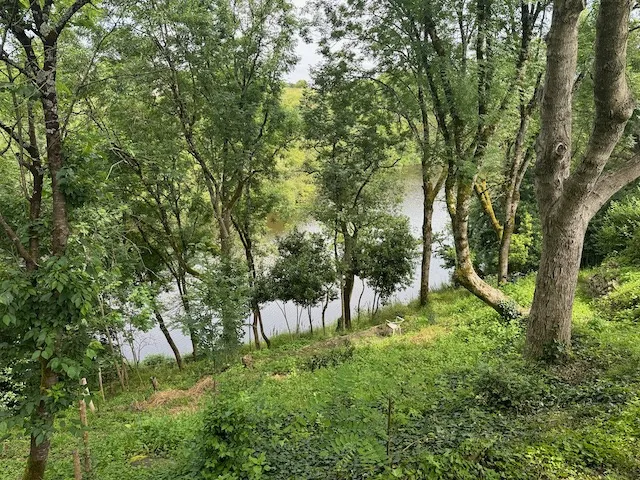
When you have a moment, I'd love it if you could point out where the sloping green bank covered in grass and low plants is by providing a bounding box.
[0,274,640,480]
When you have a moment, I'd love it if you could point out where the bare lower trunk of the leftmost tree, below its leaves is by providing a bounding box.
[22,359,58,480]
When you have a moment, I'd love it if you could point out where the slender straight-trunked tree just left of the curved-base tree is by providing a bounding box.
[318,0,447,305]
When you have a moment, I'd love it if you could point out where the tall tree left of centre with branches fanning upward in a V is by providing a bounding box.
[110,0,296,346]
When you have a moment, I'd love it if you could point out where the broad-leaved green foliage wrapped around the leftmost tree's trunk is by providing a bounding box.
[0,255,101,441]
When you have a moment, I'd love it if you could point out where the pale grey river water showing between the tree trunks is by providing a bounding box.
[125,167,451,358]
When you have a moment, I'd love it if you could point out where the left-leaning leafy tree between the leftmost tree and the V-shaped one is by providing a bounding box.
[85,68,214,358]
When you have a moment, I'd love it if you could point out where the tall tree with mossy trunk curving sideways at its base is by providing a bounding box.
[402,0,541,313]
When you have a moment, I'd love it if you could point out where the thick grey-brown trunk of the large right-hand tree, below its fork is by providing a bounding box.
[526,218,588,360]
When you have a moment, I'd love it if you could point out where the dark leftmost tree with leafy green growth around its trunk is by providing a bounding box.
[0,0,102,480]
